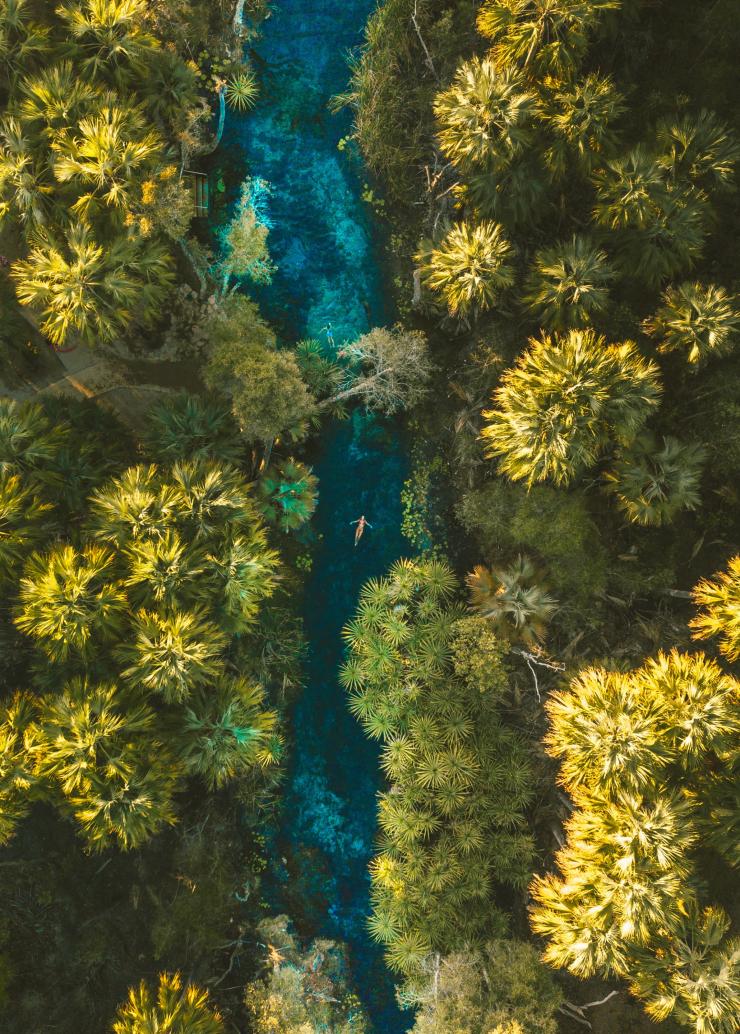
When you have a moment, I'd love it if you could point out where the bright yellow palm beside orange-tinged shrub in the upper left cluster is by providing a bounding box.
[52,105,162,219]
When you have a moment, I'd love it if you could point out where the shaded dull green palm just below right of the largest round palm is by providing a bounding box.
[605,434,706,525]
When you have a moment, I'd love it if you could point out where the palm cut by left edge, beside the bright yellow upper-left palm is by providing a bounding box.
[0,115,56,234]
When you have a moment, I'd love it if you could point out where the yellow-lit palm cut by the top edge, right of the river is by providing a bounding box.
[477,0,618,81]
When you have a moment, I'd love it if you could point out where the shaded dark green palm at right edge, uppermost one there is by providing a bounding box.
[656,111,740,190]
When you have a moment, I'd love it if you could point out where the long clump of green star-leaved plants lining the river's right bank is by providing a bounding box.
[342,560,532,977]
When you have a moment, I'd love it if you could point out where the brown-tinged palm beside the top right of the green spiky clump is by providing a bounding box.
[466,556,557,645]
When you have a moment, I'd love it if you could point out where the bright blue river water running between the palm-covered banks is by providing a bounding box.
[223,0,410,1034]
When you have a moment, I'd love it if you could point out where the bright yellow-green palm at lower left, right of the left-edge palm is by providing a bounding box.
[34,678,154,798]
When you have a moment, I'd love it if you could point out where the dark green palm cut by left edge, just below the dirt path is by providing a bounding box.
[0,396,69,480]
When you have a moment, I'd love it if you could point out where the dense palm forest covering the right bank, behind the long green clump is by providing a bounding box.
[344,0,740,1034]
